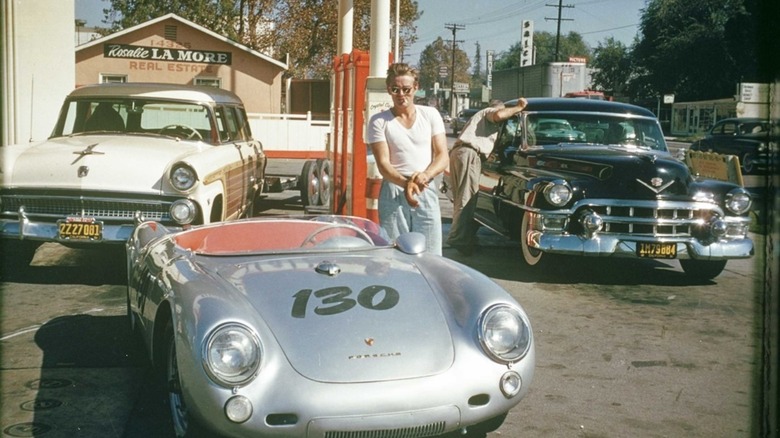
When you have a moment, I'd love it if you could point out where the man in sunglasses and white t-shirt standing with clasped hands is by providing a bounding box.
[367,63,449,255]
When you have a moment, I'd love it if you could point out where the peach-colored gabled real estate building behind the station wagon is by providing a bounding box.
[75,14,287,113]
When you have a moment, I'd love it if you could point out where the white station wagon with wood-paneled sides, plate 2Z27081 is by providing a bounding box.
[0,83,266,264]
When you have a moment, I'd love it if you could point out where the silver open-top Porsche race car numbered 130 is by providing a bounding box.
[127,215,535,438]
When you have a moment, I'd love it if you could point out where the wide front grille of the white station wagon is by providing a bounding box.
[2,195,170,222]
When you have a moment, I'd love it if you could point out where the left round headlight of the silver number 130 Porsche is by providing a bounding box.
[203,324,263,387]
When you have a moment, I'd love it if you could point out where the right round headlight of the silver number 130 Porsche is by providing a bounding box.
[479,304,531,363]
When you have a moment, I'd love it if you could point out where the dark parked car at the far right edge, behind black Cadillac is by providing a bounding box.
[690,118,778,174]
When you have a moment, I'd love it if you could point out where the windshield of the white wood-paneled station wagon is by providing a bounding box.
[53,98,211,140]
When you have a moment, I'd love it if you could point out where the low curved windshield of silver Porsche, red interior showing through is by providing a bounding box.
[174,215,391,256]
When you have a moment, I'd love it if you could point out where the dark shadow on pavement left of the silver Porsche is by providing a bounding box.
[3,314,149,437]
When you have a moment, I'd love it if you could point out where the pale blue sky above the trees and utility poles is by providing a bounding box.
[75,0,646,63]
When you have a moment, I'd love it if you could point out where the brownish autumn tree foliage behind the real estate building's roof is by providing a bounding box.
[104,0,420,78]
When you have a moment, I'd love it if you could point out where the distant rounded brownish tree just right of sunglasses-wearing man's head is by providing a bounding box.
[417,37,471,89]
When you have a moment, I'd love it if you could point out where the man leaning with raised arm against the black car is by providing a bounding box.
[447,97,528,255]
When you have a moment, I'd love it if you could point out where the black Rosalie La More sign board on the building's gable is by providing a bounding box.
[103,44,232,65]
